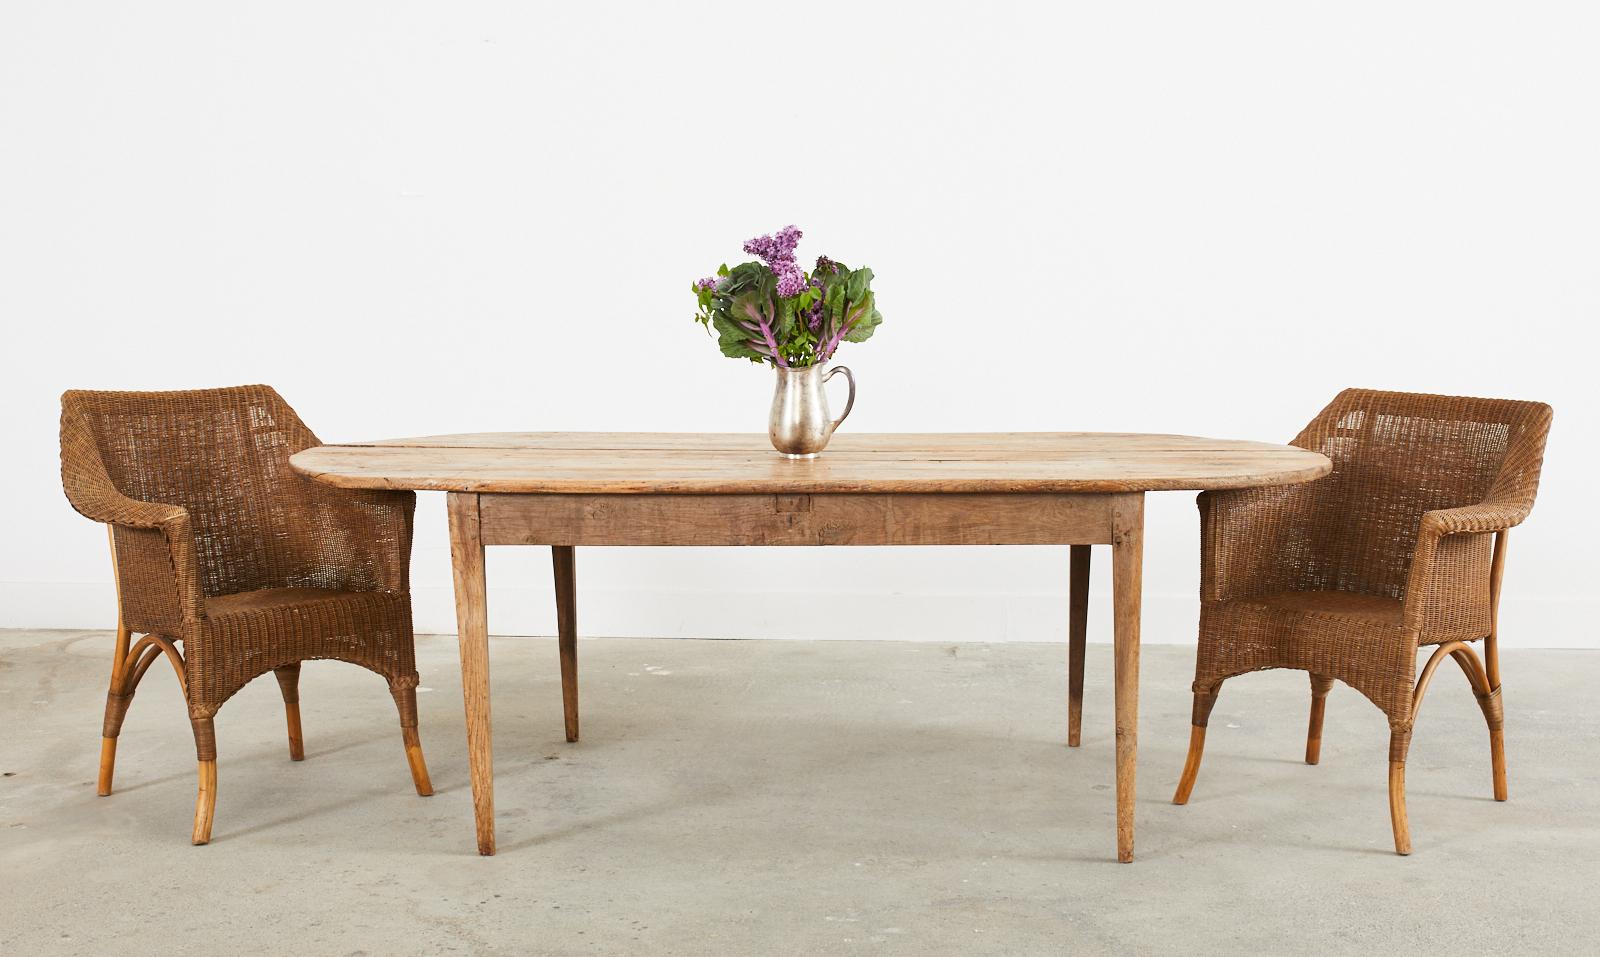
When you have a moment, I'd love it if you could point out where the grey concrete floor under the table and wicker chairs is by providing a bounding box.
[0,631,1600,955]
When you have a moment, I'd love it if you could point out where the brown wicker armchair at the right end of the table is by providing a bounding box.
[1173,389,1550,855]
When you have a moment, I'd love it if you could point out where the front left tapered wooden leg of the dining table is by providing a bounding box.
[450,491,494,856]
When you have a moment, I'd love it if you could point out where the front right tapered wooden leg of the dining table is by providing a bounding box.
[1110,495,1144,864]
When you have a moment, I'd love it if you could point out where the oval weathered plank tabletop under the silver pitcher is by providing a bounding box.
[290,432,1333,495]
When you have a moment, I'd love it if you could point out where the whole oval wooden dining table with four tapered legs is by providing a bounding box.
[290,432,1331,861]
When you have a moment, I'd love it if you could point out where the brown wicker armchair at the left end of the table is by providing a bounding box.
[61,386,434,843]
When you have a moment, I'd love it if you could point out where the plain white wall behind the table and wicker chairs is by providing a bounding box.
[0,0,1600,647]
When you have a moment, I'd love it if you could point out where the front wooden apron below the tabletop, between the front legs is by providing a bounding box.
[476,493,1142,546]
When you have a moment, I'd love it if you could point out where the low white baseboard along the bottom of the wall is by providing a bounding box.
[0,581,1600,648]
